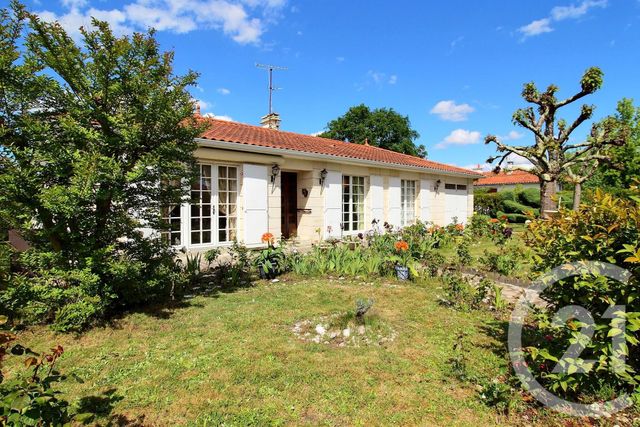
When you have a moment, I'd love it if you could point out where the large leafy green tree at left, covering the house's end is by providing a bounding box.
[0,2,201,328]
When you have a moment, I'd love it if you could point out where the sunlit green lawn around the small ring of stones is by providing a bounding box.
[10,276,506,426]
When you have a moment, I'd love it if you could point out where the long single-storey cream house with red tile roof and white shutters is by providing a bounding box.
[164,113,481,250]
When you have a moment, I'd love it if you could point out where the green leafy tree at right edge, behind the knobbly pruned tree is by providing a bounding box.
[585,98,640,193]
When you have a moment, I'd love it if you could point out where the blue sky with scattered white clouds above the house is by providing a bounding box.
[13,0,640,171]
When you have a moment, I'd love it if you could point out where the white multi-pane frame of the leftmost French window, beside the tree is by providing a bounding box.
[162,162,241,249]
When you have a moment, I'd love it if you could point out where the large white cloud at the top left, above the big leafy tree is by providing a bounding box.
[37,0,286,44]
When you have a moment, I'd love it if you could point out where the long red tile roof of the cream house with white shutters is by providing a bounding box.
[200,118,481,178]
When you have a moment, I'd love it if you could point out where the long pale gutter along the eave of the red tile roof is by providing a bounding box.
[195,138,482,179]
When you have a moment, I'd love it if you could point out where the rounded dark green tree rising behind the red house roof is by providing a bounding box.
[319,104,427,157]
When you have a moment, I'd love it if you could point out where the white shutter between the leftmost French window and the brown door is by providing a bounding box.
[242,164,269,245]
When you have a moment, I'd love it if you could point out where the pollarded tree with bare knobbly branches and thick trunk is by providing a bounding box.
[485,67,625,216]
